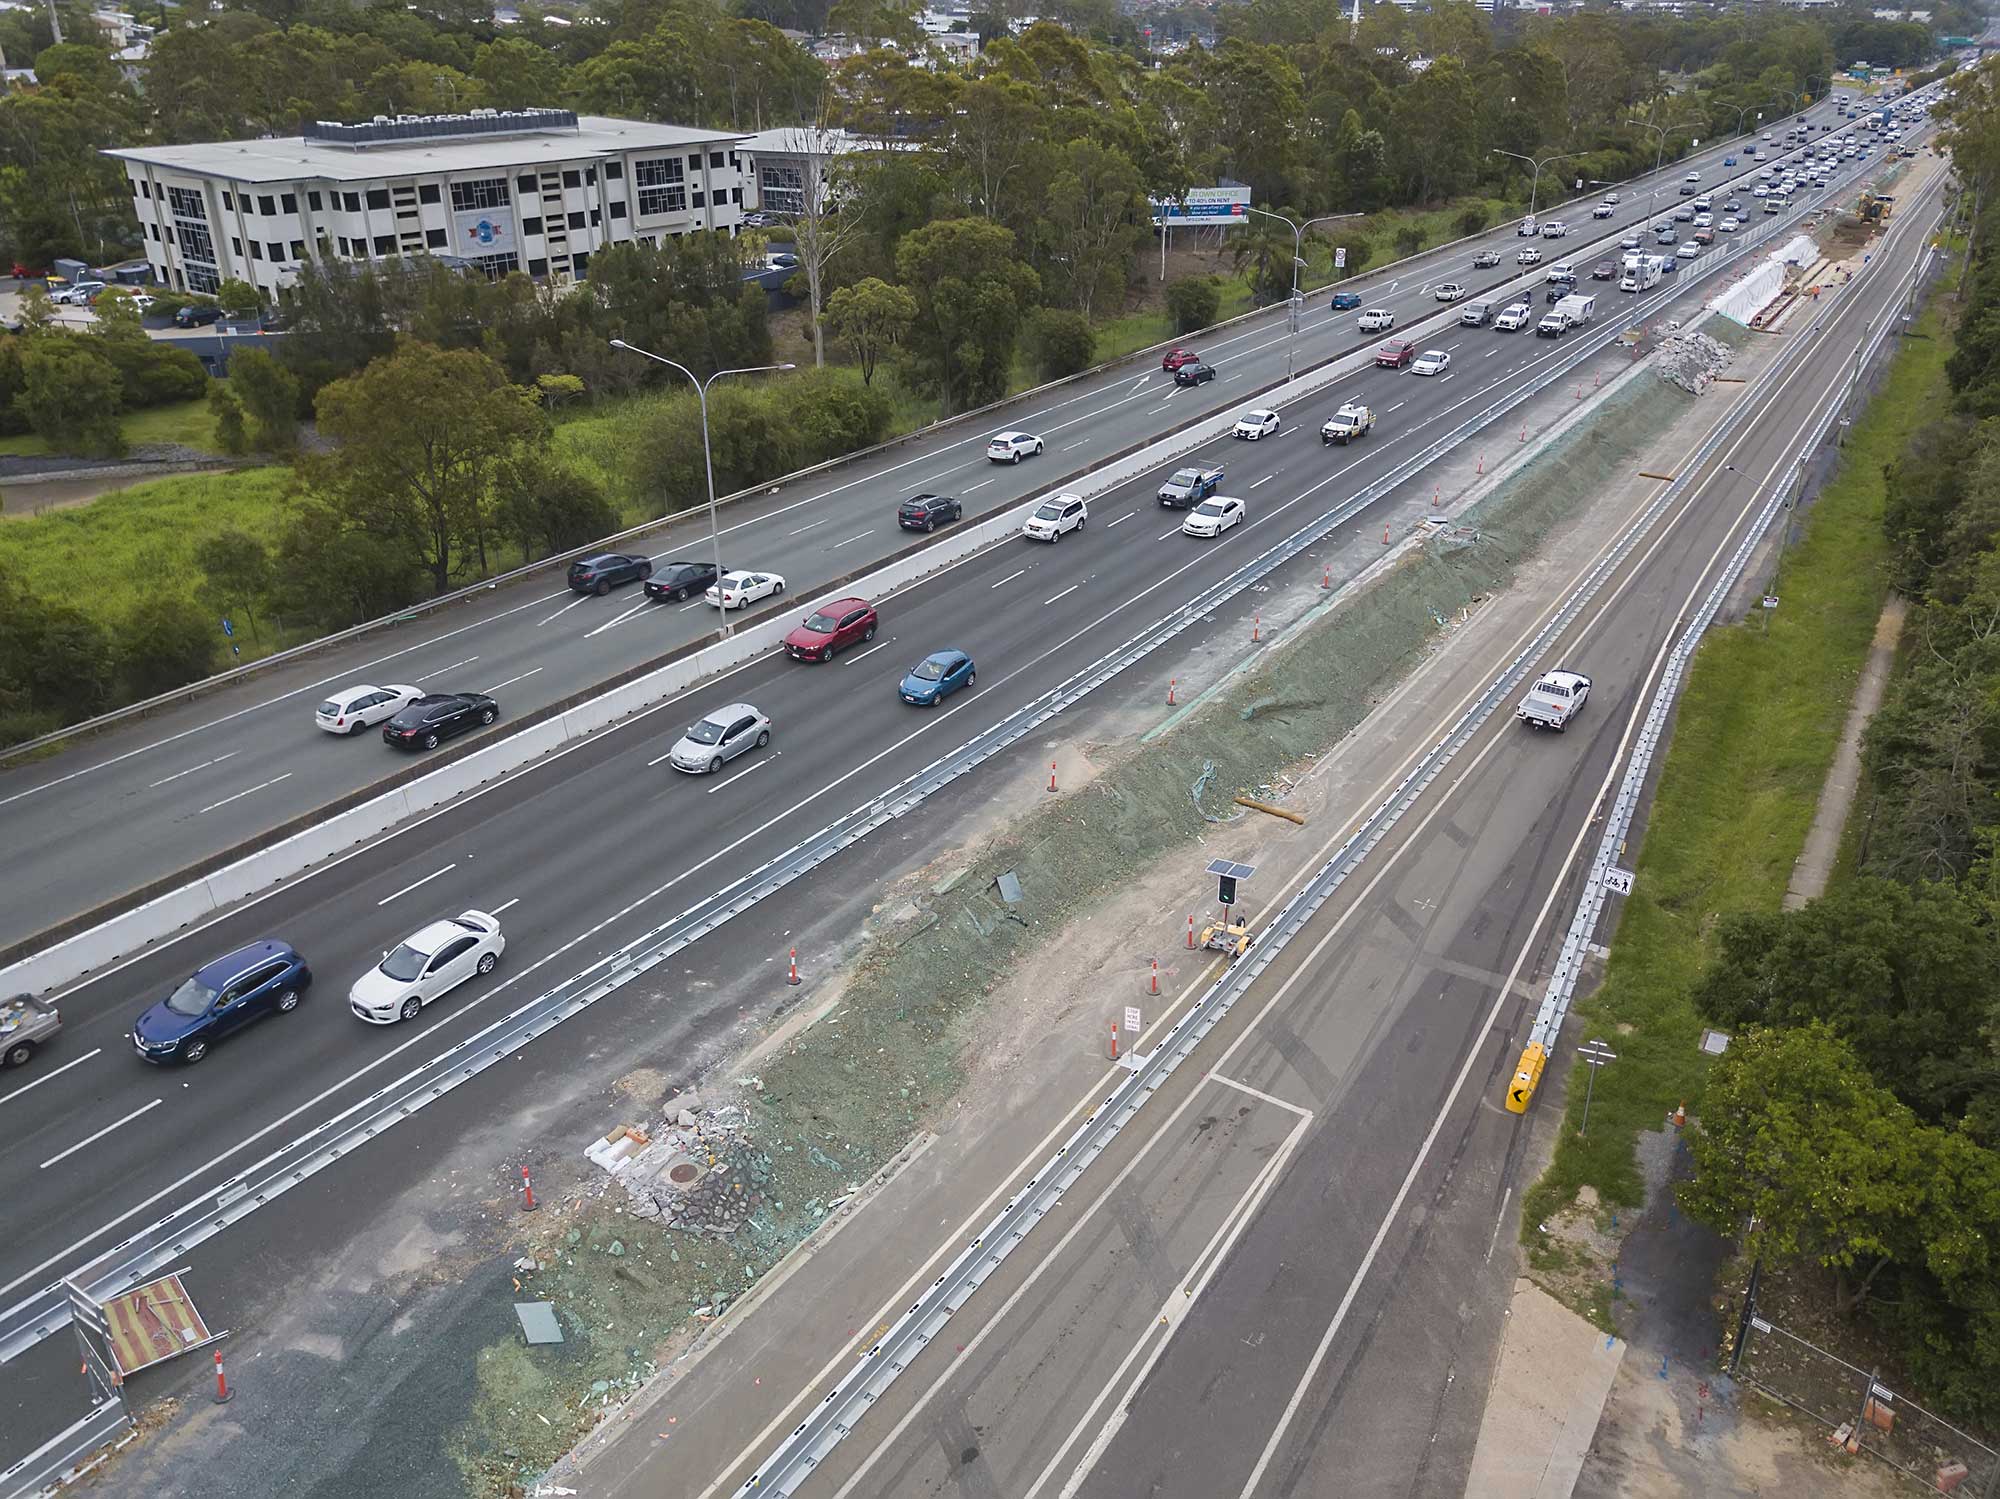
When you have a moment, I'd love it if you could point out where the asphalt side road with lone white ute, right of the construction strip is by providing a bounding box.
[732,143,1934,1499]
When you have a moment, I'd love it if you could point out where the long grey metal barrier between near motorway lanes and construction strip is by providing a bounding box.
[0,205,1768,1363]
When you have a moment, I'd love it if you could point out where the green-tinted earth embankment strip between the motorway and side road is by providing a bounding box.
[484,376,1688,1495]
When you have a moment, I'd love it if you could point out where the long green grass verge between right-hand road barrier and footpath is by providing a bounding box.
[1522,295,1952,1259]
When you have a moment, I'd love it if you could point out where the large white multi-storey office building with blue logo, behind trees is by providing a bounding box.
[106,110,744,294]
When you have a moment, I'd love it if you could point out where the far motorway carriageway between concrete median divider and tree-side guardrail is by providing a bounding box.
[0,104,1852,943]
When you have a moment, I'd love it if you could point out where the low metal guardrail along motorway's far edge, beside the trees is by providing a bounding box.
[0,102,1852,765]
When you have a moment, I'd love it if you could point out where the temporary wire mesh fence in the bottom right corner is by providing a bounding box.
[1736,1313,2000,1499]
